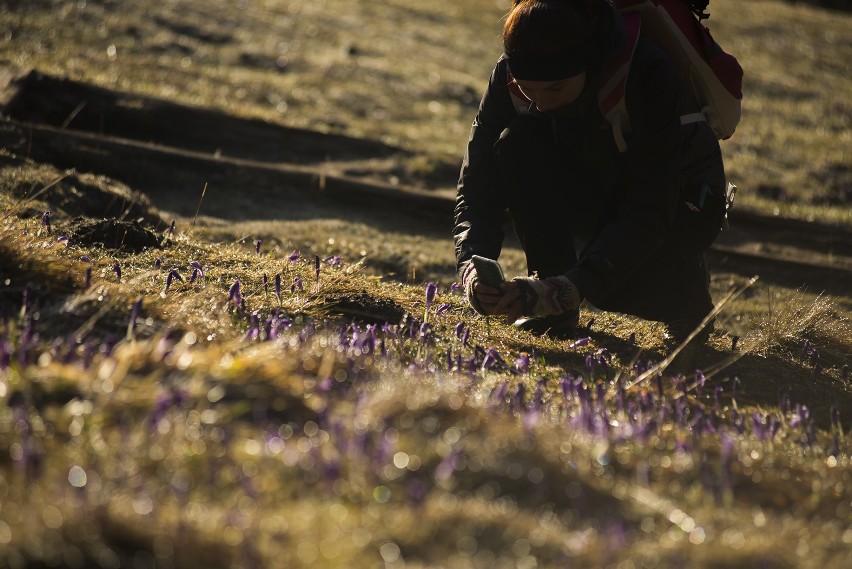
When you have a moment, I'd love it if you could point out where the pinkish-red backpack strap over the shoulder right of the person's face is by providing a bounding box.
[598,13,642,152]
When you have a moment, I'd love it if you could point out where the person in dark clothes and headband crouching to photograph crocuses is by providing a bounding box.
[454,0,726,341]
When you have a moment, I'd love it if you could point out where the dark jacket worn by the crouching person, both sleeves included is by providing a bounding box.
[453,38,724,303]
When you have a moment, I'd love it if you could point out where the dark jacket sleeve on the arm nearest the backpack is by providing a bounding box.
[566,51,682,304]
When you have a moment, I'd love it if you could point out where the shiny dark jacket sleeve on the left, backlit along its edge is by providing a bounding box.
[453,59,515,272]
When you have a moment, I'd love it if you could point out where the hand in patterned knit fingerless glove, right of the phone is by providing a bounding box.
[494,275,583,321]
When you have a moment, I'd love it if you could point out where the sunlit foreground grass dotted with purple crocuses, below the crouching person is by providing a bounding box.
[0,192,852,567]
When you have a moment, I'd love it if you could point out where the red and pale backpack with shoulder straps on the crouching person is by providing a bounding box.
[509,0,743,152]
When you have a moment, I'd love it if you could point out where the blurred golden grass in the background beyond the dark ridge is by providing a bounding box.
[0,0,852,222]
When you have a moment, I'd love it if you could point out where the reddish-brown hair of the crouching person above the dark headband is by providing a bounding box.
[503,0,623,69]
